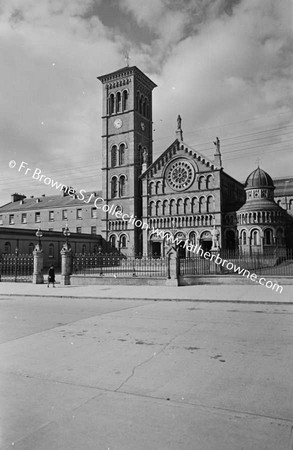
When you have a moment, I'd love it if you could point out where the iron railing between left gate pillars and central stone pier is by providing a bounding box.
[72,254,167,278]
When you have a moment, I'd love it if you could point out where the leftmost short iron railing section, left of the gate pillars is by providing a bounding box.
[0,254,34,282]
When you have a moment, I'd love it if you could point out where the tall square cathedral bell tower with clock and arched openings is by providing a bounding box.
[98,66,156,255]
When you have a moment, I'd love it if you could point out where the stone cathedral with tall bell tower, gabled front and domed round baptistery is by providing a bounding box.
[99,67,289,256]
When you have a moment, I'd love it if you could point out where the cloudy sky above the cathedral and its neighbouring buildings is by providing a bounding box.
[0,0,293,205]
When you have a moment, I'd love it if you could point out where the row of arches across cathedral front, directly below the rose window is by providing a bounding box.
[149,195,215,216]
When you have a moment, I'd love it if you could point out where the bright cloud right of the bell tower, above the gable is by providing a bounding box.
[154,0,293,172]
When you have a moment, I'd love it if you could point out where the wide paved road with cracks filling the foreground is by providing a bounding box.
[0,296,293,450]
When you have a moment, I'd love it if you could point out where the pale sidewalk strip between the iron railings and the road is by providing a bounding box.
[0,282,293,304]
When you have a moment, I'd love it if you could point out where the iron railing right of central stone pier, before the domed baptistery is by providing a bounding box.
[179,249,293,276]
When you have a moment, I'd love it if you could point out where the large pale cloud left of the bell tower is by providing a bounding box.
[0,0,121,202]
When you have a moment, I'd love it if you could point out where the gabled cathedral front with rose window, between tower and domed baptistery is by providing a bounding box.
[141,131,244,256]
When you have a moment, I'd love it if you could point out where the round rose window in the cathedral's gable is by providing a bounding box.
[166,159,194,191]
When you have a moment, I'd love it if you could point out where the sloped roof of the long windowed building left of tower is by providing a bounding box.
[0,191,101,213]
